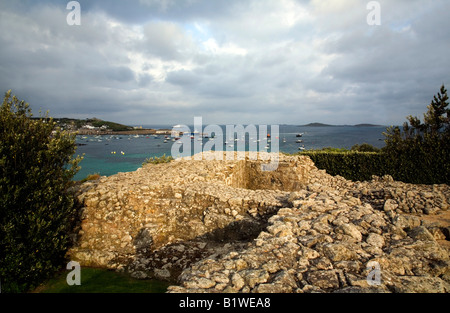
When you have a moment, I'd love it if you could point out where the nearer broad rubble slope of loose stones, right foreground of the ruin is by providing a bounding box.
[170,177,450,293]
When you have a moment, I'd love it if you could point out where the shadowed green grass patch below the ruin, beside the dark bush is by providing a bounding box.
[35,267,170,293]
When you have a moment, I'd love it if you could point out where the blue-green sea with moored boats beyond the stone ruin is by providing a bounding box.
[74,125,387,180]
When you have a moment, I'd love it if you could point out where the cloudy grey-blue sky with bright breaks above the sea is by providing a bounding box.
[0,0,450,125]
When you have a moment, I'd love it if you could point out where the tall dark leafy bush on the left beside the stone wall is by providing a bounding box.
[0,90,81,292]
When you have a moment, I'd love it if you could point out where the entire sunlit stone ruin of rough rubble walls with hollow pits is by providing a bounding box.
[69,152,450,293]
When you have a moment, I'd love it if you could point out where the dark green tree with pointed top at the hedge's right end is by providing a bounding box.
[383,85,450,184]
